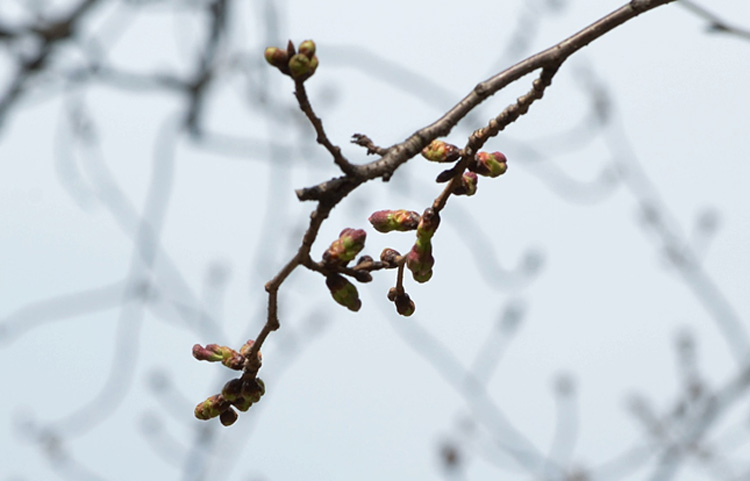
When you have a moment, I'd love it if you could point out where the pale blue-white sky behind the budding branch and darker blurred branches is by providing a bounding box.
[0,0,750,481]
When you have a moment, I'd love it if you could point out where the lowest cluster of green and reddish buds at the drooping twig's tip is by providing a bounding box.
[193,340,266,426]
